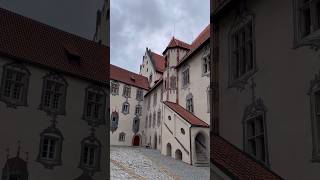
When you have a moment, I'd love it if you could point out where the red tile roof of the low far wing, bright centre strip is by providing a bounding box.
[110,64,149,90]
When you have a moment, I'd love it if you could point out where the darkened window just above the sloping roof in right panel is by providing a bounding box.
[244,99,269,165]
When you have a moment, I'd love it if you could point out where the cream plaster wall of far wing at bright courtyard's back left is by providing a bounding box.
[110,82,146,146]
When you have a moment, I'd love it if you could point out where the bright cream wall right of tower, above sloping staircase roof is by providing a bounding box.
[178,48,210,124]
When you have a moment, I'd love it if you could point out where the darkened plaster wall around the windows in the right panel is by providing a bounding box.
[218,0,320,180]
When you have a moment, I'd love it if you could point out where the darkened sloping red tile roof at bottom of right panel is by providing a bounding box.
[210,135,283,180]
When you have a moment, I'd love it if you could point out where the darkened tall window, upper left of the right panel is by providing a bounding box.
[230,16,255,81]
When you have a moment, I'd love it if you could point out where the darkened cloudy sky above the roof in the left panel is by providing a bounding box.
[0,0,103,40]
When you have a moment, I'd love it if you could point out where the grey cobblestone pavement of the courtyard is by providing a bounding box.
[110,146,210,180]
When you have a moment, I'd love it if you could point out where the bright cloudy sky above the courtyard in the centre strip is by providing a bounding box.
[110,0,210,73]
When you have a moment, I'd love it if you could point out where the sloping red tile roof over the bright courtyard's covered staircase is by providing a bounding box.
[163,101,209,127]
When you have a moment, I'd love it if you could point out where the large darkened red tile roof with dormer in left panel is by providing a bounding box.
[0,8,109,83]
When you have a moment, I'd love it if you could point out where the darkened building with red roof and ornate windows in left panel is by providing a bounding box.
[0,8,109,180]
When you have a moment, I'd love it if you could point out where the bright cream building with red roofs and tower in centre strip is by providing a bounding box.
[110,26,210,166]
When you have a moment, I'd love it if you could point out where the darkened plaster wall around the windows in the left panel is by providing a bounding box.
[0,57,109,180]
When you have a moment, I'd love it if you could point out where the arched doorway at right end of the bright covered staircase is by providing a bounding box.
[195,132,209,163]
